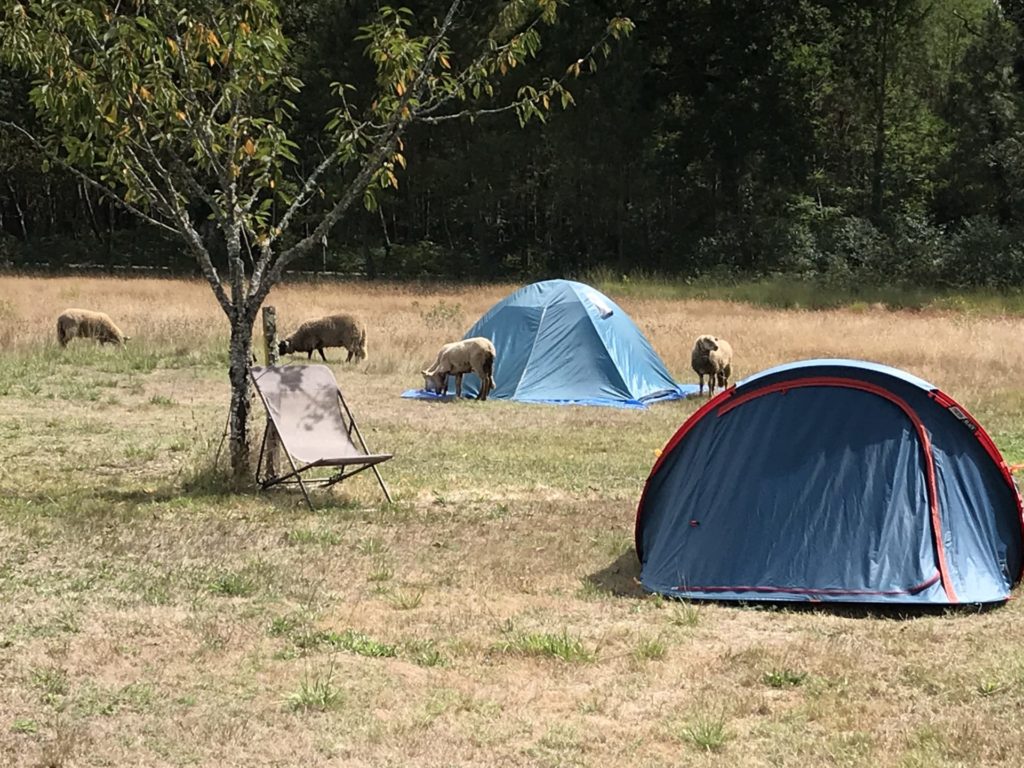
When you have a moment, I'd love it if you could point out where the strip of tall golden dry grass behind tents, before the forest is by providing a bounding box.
[0,275,1024,403]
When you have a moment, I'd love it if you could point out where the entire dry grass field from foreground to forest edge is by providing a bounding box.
[0,276,1024,768]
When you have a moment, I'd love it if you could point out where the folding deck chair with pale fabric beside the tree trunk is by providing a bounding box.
[250,366,392,510]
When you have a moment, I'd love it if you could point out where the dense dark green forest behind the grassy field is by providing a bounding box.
[0,0,1024,288]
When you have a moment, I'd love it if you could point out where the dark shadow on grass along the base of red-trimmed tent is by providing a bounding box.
[587,547,1006,622]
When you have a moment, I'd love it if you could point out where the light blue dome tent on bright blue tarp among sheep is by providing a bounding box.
[402,280,697,408]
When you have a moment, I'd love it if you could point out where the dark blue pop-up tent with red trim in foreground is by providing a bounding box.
[636,359,1022,604]
